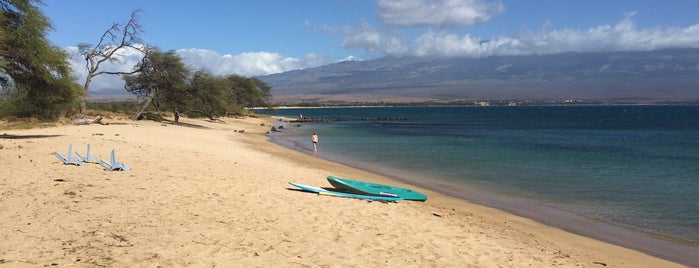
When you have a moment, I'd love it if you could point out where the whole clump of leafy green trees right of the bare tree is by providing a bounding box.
[124,62,272,119]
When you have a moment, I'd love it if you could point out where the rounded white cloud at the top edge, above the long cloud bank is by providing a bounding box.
[378,0,505,28]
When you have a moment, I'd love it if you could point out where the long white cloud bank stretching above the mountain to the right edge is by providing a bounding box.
[343,13,699,57]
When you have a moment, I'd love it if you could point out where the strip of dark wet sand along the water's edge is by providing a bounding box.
[269,117,699,266]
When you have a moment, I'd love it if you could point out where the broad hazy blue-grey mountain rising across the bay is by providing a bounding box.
[258,49,699,104]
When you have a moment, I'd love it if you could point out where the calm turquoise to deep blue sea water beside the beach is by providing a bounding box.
[258,105,699,242]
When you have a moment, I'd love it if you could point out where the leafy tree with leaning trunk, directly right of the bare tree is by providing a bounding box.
[124,49,189,118]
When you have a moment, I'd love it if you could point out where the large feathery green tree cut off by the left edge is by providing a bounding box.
[0,0,80,119]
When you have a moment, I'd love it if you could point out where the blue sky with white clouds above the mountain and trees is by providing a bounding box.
[40,0,699,90]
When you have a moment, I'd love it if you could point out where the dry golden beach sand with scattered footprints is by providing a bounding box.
[0,118,681,267]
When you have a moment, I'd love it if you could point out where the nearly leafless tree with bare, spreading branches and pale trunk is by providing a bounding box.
[78,10,148,118]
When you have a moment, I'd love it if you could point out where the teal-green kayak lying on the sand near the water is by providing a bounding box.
[328,176,427,201]
